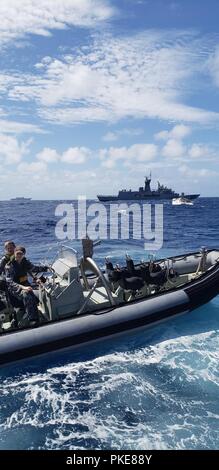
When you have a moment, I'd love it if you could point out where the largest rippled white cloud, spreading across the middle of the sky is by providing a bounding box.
[6,31,219,126]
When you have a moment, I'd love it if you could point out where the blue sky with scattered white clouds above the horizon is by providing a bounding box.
[0,0,219,199]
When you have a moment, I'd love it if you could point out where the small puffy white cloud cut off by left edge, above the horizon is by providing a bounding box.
[0,134,31,165]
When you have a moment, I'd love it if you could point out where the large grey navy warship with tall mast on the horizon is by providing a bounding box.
[97,175,200,202]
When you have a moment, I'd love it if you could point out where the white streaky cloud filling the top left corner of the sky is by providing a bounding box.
[0,0,115,45]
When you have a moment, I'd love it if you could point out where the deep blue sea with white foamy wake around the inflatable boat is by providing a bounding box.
[0,198,219,450]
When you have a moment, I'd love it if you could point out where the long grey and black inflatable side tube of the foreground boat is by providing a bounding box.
[0,263,219,365]
